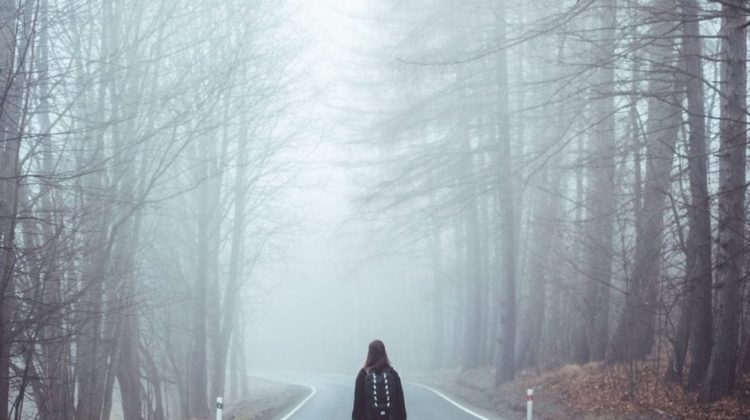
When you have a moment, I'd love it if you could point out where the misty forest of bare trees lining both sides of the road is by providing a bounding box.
[0,0,750,420]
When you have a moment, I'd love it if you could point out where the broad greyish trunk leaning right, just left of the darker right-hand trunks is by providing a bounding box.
[608,0,682,362]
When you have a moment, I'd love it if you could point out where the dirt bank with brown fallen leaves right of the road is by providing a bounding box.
[411,363,750,420]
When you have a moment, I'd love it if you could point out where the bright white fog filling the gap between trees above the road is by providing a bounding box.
[247,2,452,374]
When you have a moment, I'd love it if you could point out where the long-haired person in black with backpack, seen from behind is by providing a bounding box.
[352,340,406,420]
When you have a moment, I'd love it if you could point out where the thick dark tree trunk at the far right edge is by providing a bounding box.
[701,0,747,401]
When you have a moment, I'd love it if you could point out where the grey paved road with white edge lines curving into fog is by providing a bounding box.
[264,373,498,420]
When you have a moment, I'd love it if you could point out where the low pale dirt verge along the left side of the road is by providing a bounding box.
[224,378,310,420]
